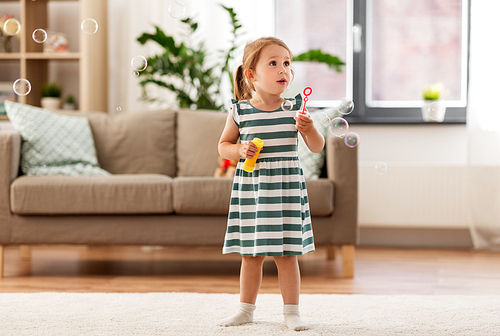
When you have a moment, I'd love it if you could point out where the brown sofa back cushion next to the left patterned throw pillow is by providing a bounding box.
[84,110,176,177]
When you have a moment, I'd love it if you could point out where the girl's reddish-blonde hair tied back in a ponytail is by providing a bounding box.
[234,36,293,101]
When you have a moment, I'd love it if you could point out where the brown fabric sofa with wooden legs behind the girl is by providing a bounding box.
[0,110,358,277]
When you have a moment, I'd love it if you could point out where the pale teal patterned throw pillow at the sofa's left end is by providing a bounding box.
[5,101,109,176]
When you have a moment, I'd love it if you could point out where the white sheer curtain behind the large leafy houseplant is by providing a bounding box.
[108,0,274,113]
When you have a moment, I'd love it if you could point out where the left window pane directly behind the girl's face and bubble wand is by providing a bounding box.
[276,0,353,107]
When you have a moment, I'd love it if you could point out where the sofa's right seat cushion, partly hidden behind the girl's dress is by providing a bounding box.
[173,176,333,216]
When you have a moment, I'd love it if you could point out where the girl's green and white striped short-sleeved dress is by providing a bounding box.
[222,94,314,256]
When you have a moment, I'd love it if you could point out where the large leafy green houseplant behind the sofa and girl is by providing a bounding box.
[137,5,345,110]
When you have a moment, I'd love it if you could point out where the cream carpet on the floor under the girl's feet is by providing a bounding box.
[0,293,500,336]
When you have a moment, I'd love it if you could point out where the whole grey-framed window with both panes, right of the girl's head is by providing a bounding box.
[276,0,470,123]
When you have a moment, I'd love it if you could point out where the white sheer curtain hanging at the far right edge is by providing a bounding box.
[467,0,500,250]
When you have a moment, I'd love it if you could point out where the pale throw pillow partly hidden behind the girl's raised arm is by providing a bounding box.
[297,108,337,180]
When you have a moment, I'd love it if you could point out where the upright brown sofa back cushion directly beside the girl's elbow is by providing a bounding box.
[177,109,227,176]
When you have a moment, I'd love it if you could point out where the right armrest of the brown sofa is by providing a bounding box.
[326,137,359,244]
